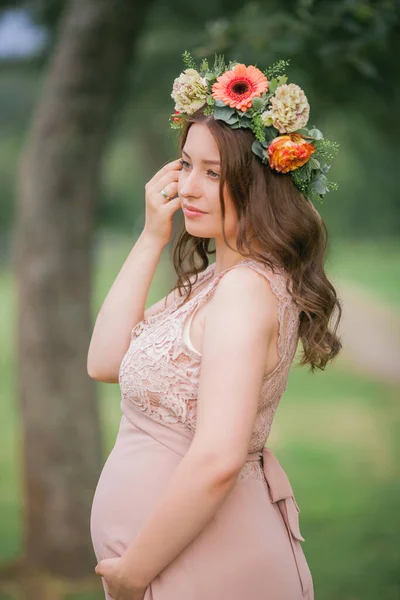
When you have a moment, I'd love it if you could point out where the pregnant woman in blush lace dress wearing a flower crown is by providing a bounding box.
[88,52,341,600]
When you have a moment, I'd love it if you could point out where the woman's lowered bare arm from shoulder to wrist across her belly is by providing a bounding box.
[115,268,277,588]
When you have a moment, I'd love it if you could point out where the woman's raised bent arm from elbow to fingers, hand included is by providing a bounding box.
[87,159,182,383]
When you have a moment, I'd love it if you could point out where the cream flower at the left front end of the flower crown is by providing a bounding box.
[171,69,208,115]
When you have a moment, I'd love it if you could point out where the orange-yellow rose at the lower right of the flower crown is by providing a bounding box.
[268,133,315,173]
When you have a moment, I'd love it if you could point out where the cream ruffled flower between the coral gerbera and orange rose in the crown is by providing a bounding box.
[263,83,310,133]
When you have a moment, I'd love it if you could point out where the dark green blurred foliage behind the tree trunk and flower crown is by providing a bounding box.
[0,0,400,248]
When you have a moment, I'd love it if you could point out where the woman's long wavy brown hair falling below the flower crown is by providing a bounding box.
[166,109,342,372]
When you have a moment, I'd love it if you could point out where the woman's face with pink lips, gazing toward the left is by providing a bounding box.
[178,123,237,240]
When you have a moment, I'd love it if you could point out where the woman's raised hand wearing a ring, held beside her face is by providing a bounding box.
[144,159,182,245]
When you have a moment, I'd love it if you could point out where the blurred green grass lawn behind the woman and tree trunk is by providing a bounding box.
[0,236,400,600]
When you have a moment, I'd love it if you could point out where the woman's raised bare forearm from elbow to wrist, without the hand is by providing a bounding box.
[87,230,164,383]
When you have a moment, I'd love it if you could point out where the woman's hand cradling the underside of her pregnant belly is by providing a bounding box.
[95,557,146,600]
